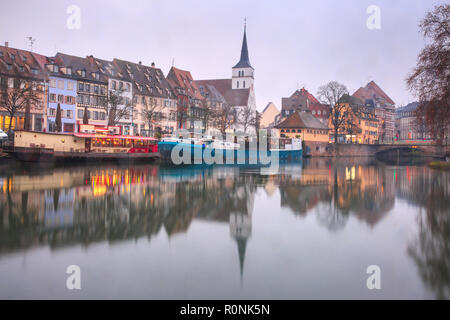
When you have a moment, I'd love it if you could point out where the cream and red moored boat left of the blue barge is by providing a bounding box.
[12,131,159,161]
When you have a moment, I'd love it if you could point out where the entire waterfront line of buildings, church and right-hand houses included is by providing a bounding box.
[0,29,429,144]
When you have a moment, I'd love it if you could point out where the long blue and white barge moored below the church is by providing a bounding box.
[158,137,303,165]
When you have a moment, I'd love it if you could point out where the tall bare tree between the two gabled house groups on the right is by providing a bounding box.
[317,81,348,143]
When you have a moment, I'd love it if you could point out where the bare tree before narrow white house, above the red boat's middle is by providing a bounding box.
[100,89,134,126]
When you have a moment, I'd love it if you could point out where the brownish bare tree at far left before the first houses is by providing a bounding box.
[0,78,41,134]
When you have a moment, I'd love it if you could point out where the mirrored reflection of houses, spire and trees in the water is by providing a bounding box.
[0,158,450,298]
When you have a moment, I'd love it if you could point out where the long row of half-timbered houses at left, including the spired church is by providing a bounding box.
[0,29,256,136]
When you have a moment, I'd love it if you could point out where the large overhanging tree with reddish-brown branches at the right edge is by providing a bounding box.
[406,4,450,143]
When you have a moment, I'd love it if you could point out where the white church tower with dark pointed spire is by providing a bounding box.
[231,24,255,89]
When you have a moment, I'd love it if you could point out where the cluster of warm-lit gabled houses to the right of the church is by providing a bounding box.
[261,81,430,144]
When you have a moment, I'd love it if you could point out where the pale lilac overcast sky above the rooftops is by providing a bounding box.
[0,0,443,110]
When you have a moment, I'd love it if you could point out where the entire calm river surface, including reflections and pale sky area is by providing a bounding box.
[0,159,450,299]
